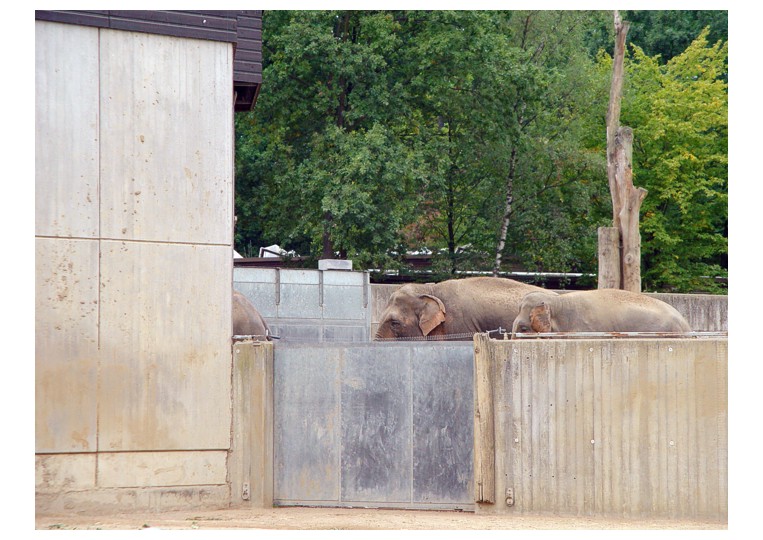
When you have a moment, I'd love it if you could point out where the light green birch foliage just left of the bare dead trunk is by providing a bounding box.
[494,11,608,272]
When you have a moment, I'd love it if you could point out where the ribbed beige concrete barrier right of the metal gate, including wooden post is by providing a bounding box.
[474,334,728,520]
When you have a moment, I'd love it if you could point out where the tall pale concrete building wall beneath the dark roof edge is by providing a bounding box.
[35,21,233,511]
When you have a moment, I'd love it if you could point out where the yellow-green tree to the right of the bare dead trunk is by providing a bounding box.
[621,29,728,292]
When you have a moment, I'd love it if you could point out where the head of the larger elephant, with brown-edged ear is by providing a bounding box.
[376,284,447,339]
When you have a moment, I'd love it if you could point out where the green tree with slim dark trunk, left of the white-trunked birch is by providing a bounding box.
[406,11,536,273]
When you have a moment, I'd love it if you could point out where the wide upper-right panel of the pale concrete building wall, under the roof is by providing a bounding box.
[100,29,233,246]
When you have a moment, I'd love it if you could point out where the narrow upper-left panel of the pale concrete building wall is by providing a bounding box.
[35,21,100,238]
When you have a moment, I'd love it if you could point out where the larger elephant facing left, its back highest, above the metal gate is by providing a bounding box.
[375,277,555,341]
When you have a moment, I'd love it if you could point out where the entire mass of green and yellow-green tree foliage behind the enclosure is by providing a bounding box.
[235,11,728,291]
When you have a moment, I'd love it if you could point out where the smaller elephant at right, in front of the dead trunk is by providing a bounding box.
[511,289,691,336]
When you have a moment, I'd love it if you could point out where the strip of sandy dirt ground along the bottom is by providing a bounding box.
[35,508,728,530]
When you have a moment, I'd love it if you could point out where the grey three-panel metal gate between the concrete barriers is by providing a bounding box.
[273,342,474,510]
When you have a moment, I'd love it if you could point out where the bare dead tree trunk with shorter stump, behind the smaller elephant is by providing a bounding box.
[599,11,647,292]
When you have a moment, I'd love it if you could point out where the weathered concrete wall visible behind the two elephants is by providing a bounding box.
[371,284,729,337]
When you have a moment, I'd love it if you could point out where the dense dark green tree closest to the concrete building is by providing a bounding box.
[237,11,416,261]
